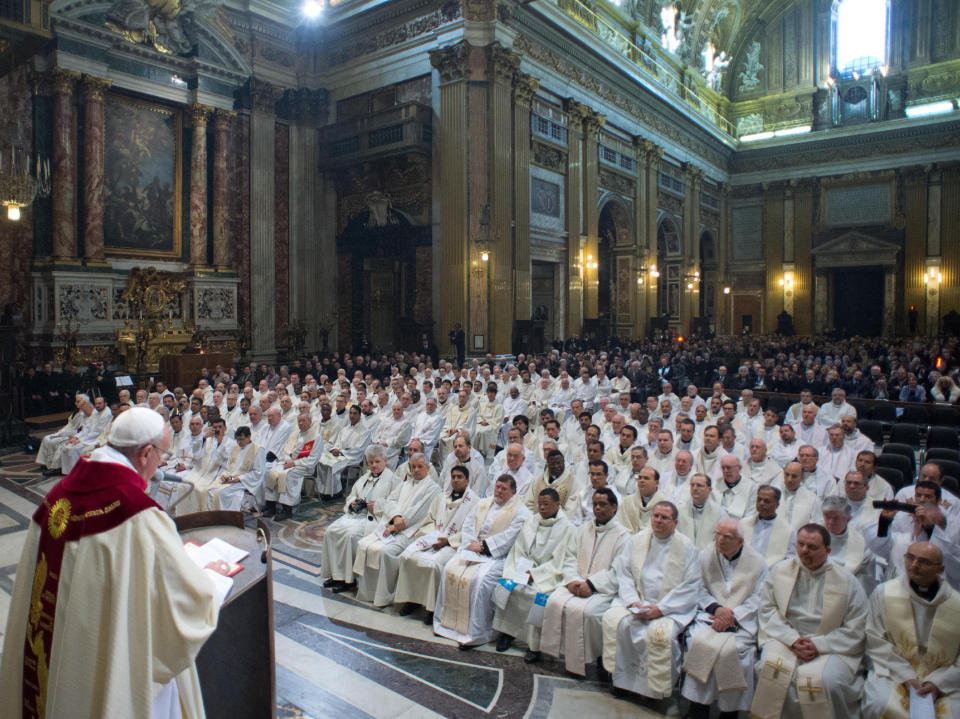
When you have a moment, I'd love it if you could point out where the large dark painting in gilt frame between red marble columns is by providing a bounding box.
[103,93,183,259]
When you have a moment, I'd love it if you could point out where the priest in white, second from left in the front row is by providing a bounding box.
[353,456,441,607]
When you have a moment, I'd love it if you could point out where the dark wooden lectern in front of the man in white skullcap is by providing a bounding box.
[174,512,277,719]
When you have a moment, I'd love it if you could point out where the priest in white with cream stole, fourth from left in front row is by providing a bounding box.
[433,475,530,647]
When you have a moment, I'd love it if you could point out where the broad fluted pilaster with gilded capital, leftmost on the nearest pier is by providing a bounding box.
[430,42,472,350]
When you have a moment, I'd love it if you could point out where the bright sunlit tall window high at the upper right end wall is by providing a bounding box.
[831,0,890,77]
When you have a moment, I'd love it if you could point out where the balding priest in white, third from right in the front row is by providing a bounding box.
[680,519,767,719]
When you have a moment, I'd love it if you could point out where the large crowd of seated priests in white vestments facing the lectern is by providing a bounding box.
[37,356,960,719]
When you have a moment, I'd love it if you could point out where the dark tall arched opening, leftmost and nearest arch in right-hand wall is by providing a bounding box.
[597,198,635,338]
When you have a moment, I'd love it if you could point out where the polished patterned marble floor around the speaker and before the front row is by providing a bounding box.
[0,453,685,719]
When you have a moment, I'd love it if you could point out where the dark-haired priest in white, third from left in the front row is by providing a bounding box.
[394,465,481,625]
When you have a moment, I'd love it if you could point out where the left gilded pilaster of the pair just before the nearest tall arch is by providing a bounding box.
[561,99,590,338]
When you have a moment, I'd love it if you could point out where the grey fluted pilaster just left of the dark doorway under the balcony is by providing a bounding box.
[288,89,328,347]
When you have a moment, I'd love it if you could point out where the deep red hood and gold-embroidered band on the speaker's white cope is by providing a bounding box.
[22,460,160,719]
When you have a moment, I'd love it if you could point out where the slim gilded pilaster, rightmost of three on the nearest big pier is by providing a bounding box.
[513,72,536,320]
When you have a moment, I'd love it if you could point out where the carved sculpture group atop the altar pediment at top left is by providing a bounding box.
[105,0,230,55]
